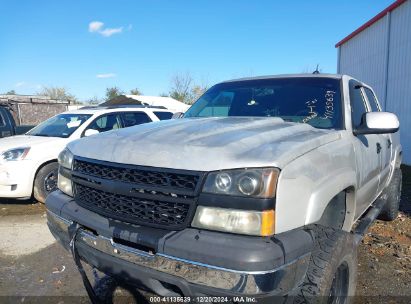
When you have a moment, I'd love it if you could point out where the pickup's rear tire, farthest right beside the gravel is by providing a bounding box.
[378,169,402,221]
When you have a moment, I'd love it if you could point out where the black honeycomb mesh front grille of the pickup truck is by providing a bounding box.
[72,158,202,230]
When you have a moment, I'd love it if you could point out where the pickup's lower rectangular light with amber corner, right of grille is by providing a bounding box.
[191,206,275,236]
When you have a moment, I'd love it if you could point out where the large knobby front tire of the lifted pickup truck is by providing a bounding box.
[294,225,357,304]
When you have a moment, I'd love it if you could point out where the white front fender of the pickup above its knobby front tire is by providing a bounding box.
[276,137,358,233]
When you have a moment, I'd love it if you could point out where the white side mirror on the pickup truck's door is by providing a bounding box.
[354,112,400,135]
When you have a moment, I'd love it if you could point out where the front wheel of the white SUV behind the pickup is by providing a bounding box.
[33,162,58,203]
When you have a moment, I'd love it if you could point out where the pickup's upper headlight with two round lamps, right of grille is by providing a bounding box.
[203,168,279,198]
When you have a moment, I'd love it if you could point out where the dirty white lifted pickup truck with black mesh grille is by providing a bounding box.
[46,75,402,303]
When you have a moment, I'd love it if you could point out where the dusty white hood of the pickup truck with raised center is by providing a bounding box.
[68,117,340,171]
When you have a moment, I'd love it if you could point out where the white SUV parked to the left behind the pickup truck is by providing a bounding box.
[0,106,173,202]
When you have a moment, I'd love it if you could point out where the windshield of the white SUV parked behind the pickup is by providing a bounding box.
[26,114,91,138]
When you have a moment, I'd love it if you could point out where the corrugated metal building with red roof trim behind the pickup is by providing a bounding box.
[335,0,411,165]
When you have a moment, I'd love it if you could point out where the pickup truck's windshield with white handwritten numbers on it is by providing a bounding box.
[184,77,342,129]
